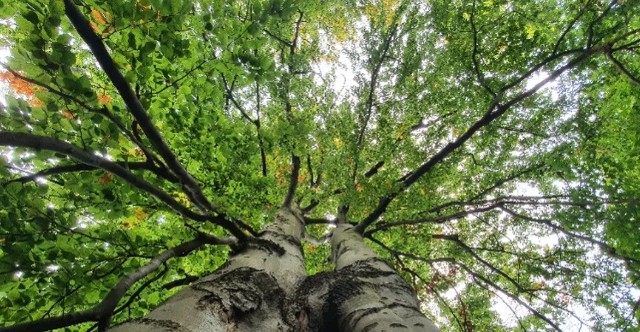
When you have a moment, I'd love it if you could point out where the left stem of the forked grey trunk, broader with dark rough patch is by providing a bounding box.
[110,208,306,332]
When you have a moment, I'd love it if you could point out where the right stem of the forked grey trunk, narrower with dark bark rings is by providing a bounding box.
[330,224,439,332]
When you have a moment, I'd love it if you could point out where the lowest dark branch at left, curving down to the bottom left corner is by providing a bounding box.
[0,234,235,332]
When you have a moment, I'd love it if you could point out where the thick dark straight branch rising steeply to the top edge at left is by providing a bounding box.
[64,0,214,212]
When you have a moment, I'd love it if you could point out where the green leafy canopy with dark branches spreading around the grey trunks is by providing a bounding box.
[0,0,640,331]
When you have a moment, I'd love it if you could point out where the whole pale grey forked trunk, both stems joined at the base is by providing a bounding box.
[110,208,438,332]
